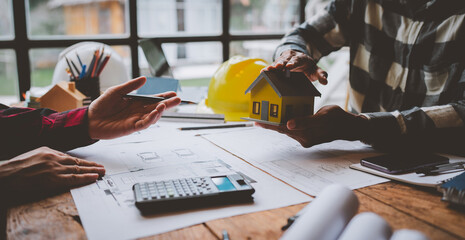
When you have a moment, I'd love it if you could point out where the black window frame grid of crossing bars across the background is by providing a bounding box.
[0,0,307,101]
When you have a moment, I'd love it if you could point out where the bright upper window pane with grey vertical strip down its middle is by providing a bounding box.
[137,0,221,37]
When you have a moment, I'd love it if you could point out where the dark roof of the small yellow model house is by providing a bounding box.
[245,71,321,97]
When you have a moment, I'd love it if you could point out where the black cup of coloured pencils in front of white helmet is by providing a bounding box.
[65,47,111,101]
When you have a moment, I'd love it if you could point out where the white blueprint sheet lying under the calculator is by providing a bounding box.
[70,131,311,239]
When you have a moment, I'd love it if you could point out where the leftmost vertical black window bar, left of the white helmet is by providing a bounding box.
[11,1,31,101]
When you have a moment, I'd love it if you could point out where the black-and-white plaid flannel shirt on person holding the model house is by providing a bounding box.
[275,0,465,152]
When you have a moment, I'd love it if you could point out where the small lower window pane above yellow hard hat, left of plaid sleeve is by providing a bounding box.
[230,40,280,63]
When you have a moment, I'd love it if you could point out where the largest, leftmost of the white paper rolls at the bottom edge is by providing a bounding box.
[281,184,359,240]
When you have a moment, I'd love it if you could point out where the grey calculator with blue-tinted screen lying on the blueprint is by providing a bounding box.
[132,174,255,214]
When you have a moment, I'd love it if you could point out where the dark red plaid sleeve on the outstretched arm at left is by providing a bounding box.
[0,104,95,160]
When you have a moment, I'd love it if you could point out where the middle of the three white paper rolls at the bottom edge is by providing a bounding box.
[339,212,392,240]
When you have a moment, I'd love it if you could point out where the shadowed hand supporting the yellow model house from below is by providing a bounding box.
[256,106,368,148]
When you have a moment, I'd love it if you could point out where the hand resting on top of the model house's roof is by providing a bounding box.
[262,50,328,85]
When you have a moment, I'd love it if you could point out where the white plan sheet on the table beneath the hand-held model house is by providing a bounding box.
[203,127,389,196]
